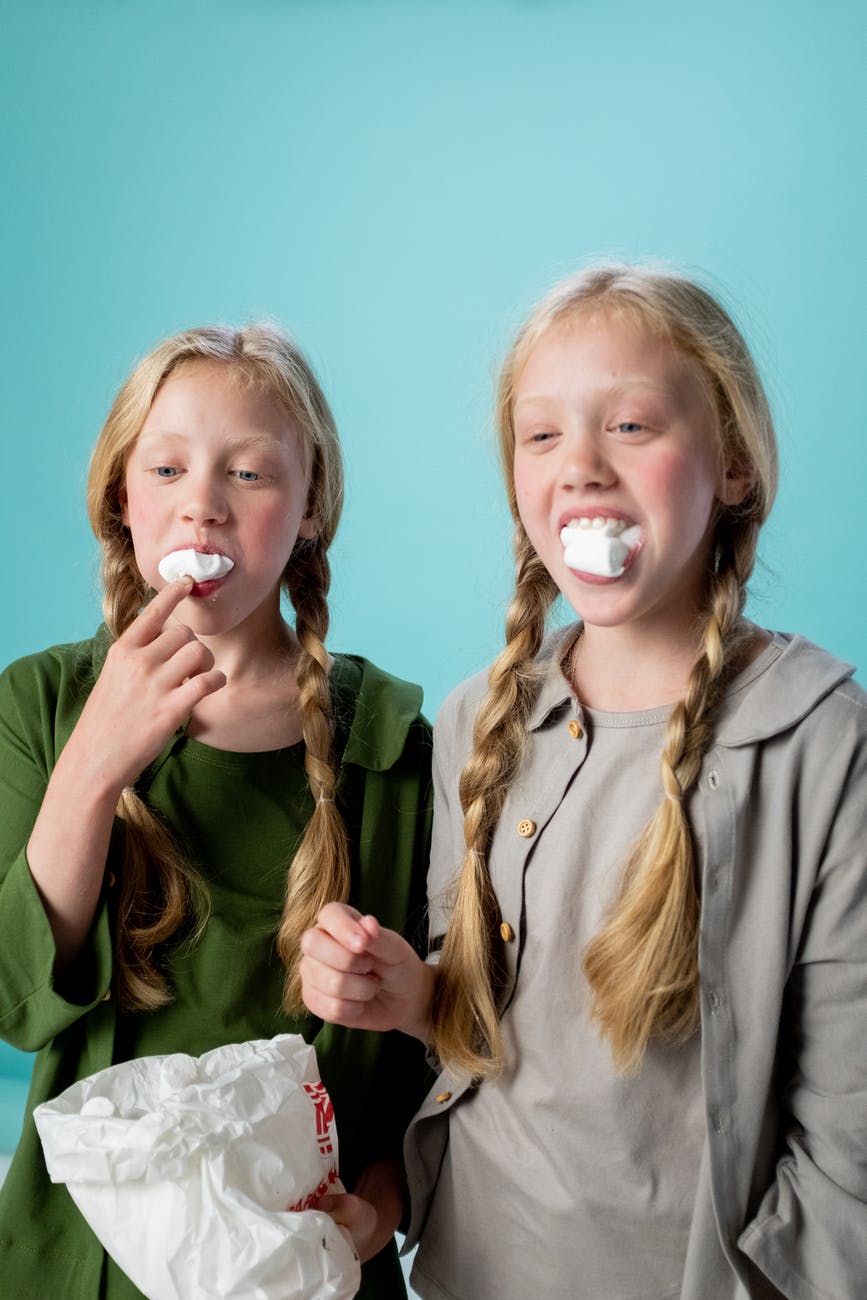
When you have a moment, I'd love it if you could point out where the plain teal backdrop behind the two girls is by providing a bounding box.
[0,0,867,1170]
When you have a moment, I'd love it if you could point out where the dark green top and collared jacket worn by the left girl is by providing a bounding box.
[0,631,430,1300]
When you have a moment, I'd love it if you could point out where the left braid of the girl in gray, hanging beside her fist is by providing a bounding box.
[432,524,556,1076]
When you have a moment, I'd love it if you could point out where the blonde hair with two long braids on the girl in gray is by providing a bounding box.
[433,265,777,1078]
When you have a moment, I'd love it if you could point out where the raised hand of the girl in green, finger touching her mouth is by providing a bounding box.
[66,577,226,797]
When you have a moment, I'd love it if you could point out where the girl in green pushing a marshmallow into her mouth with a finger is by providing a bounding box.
[0,325,430,1297]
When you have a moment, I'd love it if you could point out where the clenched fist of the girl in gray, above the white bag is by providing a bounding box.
[300,902,435,1043]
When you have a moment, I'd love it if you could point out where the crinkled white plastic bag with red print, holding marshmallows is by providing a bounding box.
[34,1034,360,1300]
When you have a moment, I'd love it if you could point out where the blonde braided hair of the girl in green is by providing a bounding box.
[87,322,350,1011]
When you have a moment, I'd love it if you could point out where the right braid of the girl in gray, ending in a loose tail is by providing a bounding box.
[584,523,758,1074]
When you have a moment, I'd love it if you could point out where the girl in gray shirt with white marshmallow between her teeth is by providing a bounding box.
[302,267,867,1300]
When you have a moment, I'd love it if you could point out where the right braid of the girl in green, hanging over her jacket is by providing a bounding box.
[277,541,350,1011]
